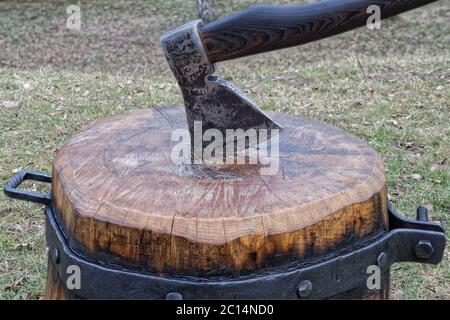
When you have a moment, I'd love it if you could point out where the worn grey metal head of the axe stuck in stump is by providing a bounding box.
[160,20,281,153]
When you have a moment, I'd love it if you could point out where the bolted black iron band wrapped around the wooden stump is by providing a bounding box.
[45,202,446,299]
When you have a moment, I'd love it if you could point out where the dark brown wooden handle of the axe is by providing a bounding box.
[199,0,436,63]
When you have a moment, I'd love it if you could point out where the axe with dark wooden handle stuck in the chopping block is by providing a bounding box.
[160,0,435,147]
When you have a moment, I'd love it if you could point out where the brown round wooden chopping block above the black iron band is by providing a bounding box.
[52,106,387,276]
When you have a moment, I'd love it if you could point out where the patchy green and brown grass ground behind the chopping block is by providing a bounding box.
[0,0,450,299]
